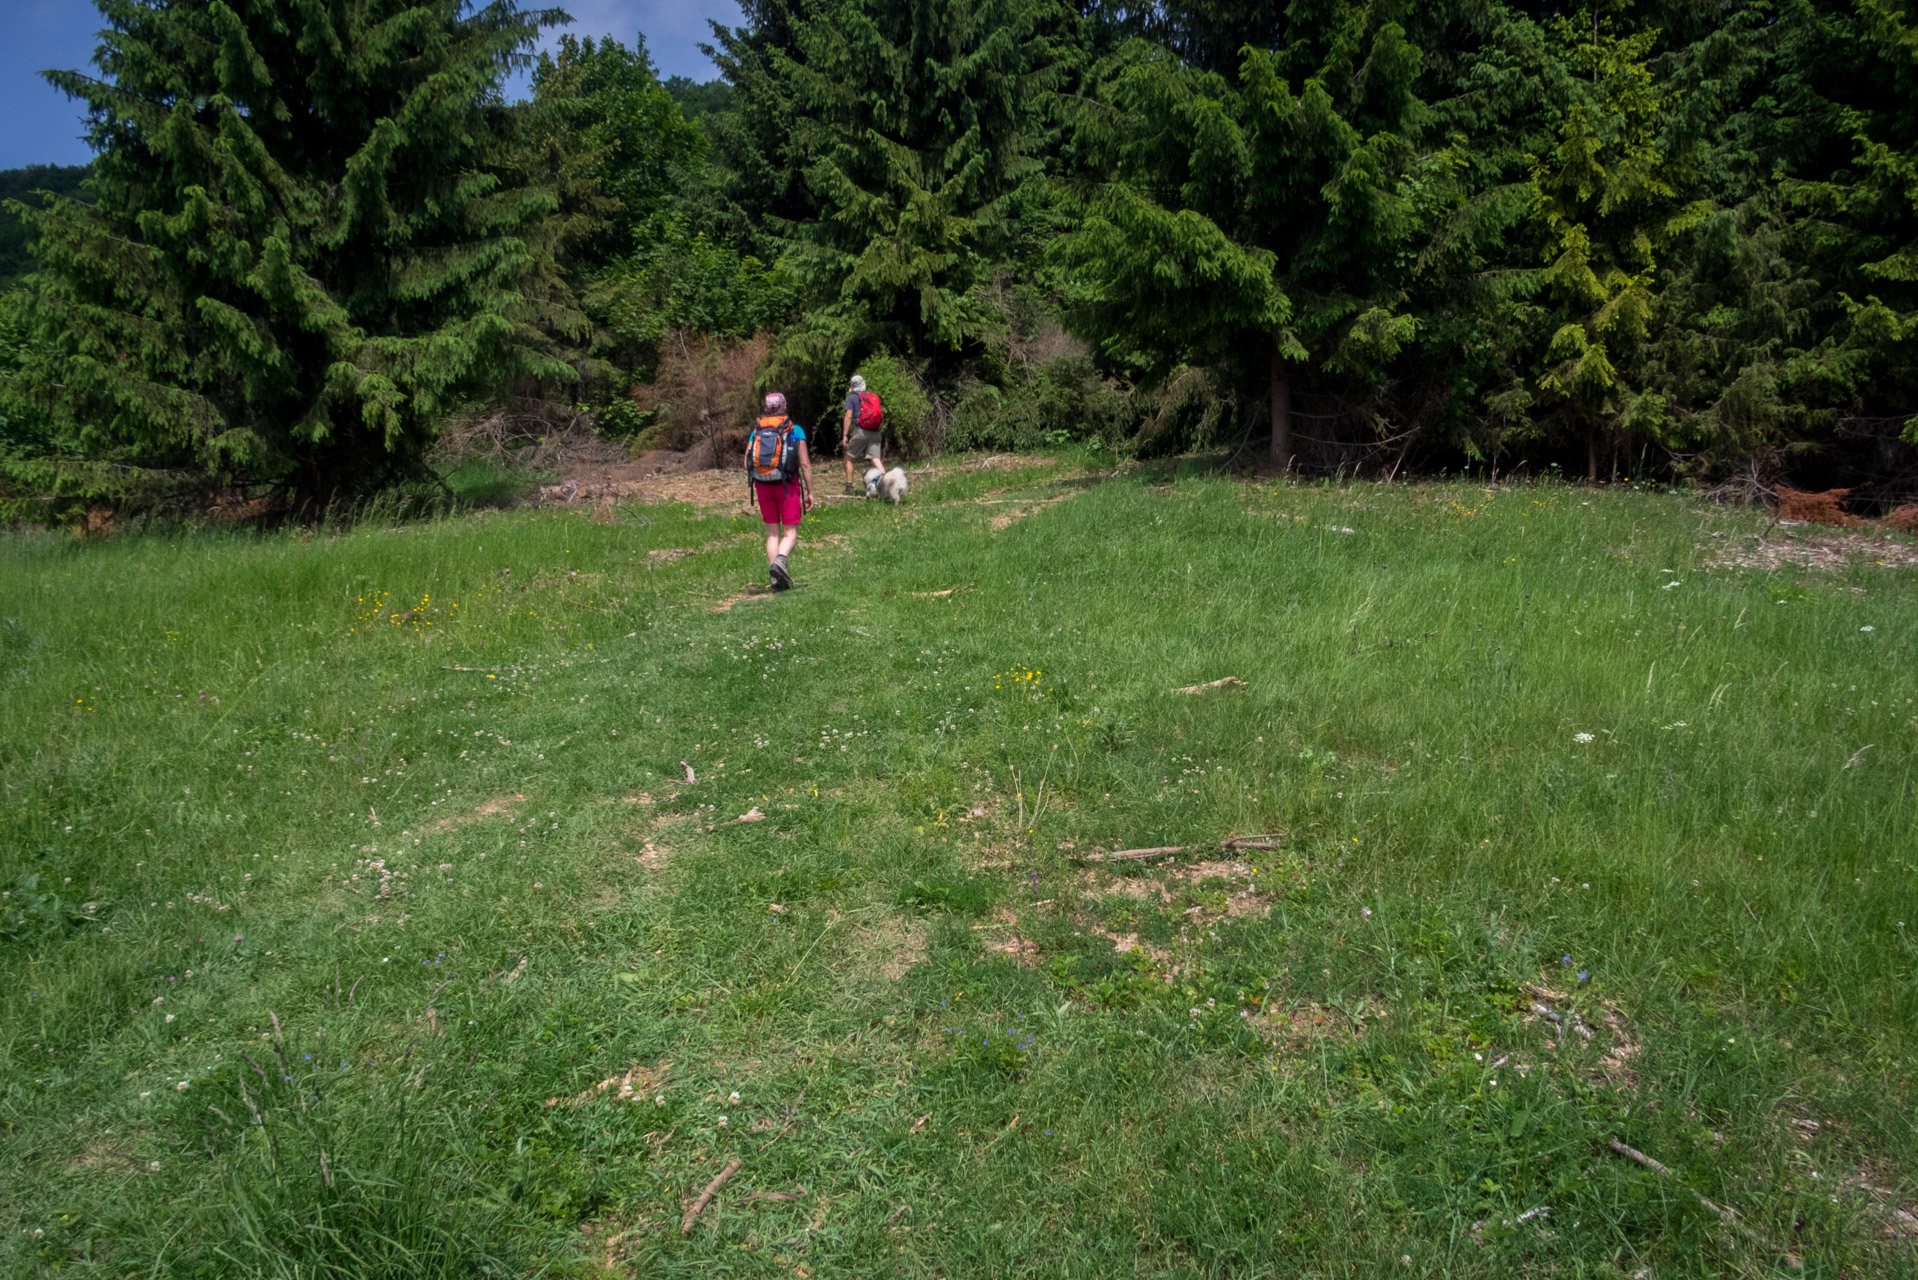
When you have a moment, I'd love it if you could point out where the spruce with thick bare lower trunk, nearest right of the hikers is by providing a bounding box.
[1055,0,1450,466]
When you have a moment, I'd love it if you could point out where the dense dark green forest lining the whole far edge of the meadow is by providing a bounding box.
[0,0,1918,516]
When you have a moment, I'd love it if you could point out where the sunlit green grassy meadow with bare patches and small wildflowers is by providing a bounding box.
[0,459,1918,1280]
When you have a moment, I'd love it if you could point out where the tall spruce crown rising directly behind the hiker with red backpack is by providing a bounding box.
[771,0,1066,355]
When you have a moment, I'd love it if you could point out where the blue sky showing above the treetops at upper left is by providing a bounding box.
[0,0,738,169]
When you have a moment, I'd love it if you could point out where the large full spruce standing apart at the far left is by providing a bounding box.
[8,0,570,503]
